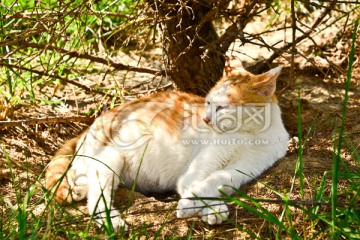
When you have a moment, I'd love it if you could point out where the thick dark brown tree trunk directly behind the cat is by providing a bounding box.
[149,0,228,96]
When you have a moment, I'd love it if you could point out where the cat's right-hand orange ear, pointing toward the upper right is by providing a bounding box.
[250,66,282,97]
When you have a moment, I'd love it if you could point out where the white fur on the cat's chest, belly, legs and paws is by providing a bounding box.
[68,69,289,229]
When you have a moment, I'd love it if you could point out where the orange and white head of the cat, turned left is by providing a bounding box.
[203,67,282,132]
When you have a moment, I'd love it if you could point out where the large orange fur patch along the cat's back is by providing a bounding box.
[94,92,204,145]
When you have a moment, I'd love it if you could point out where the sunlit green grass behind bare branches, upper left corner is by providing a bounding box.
[0,0,147,106]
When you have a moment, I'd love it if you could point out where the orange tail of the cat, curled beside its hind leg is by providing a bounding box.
[45,130,87,204]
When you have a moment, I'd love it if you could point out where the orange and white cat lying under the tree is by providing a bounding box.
[45,67,289,230]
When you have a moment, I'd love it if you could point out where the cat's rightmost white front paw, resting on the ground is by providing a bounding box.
[201,201,229,225]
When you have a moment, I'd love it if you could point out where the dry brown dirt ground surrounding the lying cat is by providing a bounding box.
[0,20,360,239]
